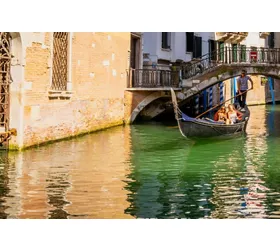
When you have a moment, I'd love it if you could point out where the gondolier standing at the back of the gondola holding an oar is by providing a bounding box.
[237,70,253,111]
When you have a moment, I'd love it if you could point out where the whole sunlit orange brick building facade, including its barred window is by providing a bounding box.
[0,32,135,149]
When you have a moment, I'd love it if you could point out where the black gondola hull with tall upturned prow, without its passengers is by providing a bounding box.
[171,89,250,138]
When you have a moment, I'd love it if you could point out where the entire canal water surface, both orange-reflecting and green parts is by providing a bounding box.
[0,105,280,219]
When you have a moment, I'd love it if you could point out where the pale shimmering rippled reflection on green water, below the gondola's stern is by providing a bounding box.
[211,106,269,218]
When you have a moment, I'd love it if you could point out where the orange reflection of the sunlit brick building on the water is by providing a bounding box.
[0,127,131,218]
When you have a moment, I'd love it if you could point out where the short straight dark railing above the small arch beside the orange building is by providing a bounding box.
[128,69,180,88]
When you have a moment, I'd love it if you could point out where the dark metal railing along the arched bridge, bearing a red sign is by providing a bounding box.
[182,47,280,79]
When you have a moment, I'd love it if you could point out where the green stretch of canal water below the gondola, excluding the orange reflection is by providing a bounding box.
[126,106,280,218]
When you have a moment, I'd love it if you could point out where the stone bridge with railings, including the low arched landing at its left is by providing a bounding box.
[126,47,280,123]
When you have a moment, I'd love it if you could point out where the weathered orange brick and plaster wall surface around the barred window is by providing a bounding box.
[11,32,130,148]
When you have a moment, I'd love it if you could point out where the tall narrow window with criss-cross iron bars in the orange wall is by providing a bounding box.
[51,32,69,91]
